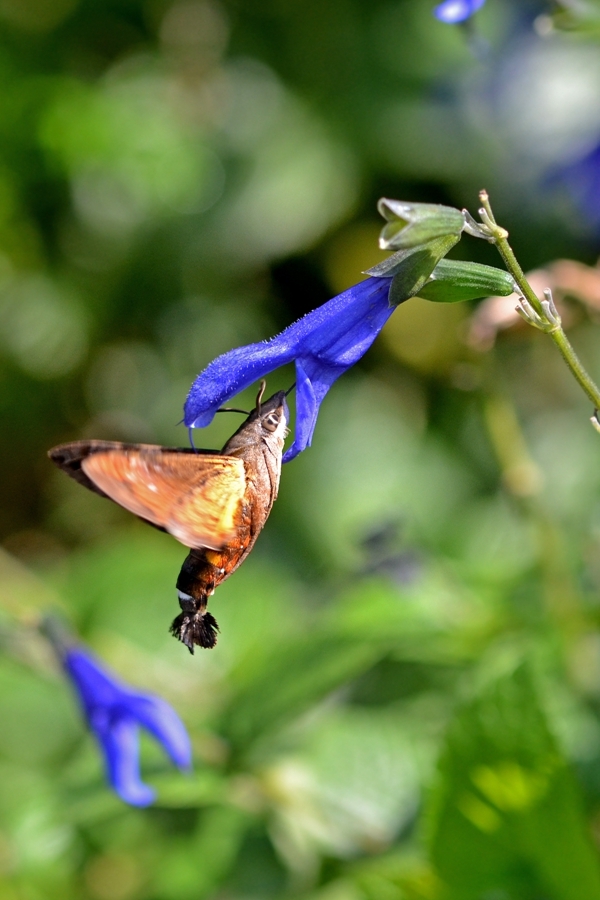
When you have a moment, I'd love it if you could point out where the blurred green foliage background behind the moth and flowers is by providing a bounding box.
[5,0,600,900]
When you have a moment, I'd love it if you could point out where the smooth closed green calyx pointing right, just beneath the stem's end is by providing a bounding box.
[419,259,517,303]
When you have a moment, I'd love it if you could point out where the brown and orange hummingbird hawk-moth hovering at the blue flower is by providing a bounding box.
[48,384,289,653]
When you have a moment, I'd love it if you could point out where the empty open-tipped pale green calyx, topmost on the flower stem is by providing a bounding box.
[377,197,465,250]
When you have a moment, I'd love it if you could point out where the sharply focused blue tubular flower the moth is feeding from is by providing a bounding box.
[183,277,395,462]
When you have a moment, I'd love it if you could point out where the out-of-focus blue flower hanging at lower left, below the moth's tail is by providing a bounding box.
[61,647,192,806]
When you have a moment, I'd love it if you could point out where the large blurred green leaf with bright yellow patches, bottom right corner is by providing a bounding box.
[429,666,600,900]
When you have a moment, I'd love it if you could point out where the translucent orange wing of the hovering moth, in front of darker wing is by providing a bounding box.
[81,446,246,550]
